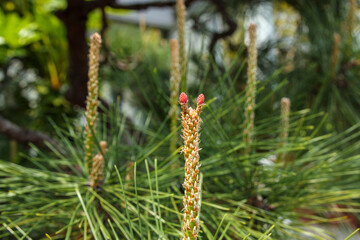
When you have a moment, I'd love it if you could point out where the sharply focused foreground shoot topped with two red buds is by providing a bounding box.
[179,93,205,240]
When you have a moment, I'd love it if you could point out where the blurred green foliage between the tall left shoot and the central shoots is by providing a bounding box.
[101,24,170,124]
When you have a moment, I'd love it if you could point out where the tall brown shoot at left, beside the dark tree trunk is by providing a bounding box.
[85,33,101,173]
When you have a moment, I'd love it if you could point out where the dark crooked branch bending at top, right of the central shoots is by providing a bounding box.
[209,0,237,54]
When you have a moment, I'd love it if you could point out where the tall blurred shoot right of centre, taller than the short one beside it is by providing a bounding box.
[243,24,257,156]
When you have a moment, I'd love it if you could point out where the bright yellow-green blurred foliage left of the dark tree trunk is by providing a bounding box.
[0,1,71,135]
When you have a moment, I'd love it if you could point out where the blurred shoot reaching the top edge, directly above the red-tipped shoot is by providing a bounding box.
[176,0,187,92]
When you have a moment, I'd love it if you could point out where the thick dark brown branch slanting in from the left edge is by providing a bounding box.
[0,116,58,148]
